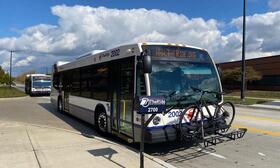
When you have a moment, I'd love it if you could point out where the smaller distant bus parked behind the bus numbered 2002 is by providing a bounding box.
[25,74,51,96]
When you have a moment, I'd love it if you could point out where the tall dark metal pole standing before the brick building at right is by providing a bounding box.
[240,0,246,101]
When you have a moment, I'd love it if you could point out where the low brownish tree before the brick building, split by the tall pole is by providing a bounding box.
[221,66,262,85]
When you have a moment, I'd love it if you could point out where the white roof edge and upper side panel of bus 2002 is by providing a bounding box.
[56,42,205,72]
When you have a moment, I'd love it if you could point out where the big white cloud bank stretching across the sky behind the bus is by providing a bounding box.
[0,5,280,73]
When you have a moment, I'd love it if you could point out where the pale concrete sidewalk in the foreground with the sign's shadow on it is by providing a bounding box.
[0,121,173,168]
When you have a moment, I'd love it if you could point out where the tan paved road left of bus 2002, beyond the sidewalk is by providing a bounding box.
[0,96,96,135]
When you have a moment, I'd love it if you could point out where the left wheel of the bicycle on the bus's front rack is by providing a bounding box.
[179,105,198,140]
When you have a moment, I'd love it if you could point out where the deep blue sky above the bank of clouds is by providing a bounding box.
[0,0,268,37]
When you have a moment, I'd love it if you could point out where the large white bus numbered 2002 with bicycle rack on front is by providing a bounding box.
[51,43,222,143]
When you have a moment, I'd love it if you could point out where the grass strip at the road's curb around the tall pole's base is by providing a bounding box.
[224,96,271,105]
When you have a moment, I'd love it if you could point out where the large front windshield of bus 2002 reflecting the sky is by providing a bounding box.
[144,46,221,105]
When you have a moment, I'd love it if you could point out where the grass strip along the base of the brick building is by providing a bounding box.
[227,90,280,99]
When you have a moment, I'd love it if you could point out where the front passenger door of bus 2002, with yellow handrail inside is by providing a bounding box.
[110,57,134,137]
